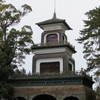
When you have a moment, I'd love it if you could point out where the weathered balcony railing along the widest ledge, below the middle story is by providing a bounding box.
[12,70,92,80]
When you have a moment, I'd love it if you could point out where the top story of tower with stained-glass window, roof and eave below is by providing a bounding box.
[32,13,76,54]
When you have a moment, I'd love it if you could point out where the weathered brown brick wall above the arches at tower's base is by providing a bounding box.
[14,85,95,100]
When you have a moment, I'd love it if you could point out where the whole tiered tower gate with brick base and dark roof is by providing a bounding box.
[10,13,95,100]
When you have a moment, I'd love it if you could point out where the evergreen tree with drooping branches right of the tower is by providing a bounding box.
[77,7,100,100]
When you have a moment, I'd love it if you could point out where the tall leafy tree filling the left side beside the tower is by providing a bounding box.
[0,0,33,100]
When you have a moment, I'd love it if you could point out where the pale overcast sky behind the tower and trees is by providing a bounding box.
[6,0,100,72]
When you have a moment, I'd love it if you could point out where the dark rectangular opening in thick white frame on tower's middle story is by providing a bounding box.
[40,62,60,74]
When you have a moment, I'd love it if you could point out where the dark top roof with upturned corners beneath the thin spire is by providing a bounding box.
[36,13,72,30]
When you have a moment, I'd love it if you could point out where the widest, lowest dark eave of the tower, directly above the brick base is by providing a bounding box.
[9,74,94,81]
